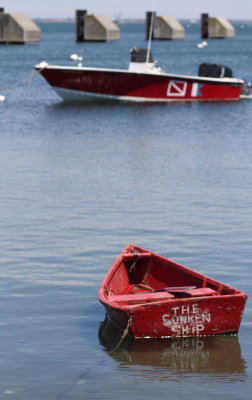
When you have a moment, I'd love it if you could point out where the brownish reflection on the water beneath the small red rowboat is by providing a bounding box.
[99,319,246,381]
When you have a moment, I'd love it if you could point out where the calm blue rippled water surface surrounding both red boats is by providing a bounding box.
[0,23,252,400]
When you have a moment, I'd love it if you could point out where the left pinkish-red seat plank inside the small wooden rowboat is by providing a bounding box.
[109,291,174,303]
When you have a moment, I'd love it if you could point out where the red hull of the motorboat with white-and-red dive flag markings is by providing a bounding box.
[37,65,244,102]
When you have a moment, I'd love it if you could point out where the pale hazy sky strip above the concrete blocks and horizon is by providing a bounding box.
[0,0,252,19]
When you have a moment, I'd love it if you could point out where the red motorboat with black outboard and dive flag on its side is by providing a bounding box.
[35,48,247,102]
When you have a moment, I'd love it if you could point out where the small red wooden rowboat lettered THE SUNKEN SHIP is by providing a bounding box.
[99,245,248,338]
